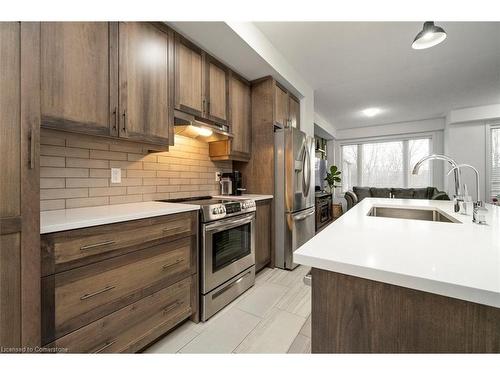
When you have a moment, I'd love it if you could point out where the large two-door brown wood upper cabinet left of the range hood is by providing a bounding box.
[41,22,174,147]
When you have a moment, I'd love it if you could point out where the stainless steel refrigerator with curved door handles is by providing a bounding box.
[274,127,315,270]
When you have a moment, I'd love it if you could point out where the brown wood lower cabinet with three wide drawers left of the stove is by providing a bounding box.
[42,212,198,353]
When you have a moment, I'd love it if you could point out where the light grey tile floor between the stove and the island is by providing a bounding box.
[145,266,311,353]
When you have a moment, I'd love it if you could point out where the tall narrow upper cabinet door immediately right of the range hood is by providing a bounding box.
[231,76,252,160]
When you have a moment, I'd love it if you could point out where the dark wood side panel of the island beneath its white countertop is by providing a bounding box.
[312,268,500,353]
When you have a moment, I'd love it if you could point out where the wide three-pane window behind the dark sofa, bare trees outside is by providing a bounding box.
[342,138,432,191]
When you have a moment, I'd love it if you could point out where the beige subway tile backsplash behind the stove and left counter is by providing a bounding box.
[40,129,232,211]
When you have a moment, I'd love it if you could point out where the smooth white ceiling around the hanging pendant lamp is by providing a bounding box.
[256,22,500,129]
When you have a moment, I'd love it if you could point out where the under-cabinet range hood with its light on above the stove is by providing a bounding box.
[174,110,233,142]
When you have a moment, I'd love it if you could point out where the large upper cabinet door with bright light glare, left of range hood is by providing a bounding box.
[119,22,173,145]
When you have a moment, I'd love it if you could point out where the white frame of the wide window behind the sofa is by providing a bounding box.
[339,132,434,193]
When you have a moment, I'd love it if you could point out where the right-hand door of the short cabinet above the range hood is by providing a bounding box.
[205,55,229,124]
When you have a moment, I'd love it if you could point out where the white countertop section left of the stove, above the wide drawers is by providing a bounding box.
[40,201,200,234]
